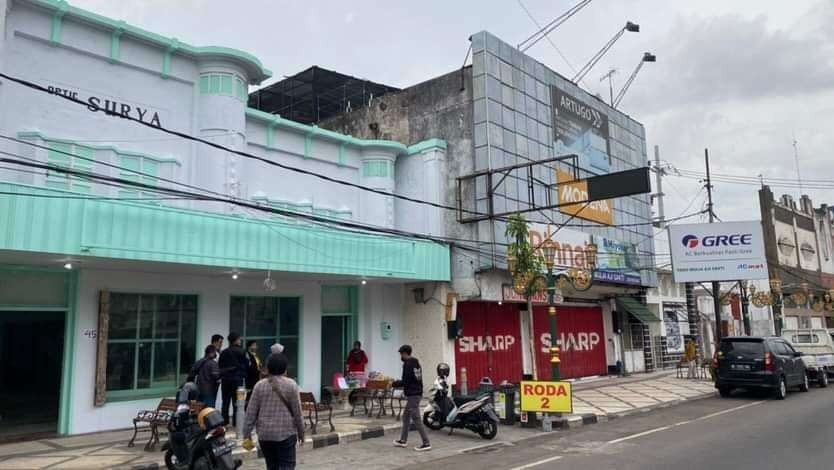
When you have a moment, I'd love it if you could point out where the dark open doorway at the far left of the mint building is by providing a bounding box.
[0,311,65,442]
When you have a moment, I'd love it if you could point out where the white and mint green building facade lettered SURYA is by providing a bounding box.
[0,0,451,434]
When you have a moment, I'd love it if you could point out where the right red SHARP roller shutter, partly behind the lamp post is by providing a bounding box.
[533,306,608,379]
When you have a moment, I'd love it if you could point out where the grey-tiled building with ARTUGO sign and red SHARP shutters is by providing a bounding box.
[302,31,658,386]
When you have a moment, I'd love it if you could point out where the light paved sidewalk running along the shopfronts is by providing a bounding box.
[0,371,715,470]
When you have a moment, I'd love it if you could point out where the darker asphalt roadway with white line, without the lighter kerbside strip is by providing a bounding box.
[399,387,834,470]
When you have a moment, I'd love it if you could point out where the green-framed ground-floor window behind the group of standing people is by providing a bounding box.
[229,296,301,378]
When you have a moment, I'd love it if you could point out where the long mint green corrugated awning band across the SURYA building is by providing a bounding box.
[0,182,451,281]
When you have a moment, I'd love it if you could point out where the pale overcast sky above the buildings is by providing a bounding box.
[71,0,834,258]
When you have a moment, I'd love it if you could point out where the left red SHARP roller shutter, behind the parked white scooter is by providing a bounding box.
[455,302,522,390]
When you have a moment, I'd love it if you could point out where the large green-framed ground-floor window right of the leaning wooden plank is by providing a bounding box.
[106,292,197,398]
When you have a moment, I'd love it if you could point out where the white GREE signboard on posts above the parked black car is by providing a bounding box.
[669,221,768,282]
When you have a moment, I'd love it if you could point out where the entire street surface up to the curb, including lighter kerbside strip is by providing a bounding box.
[244,386,834,470]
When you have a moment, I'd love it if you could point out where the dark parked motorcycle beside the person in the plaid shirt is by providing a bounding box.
[162,382,243,470]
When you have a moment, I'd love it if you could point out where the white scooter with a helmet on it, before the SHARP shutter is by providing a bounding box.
[423,363,498,439]
